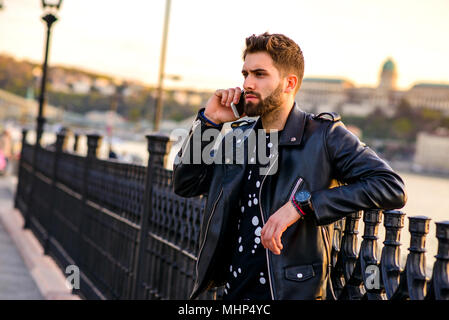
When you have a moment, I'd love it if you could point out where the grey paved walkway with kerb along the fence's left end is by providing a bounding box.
[0,176,79,300]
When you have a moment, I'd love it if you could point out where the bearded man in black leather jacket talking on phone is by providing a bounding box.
[173,33,406,300]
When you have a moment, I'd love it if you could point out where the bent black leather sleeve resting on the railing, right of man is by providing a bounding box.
[312,122,407,225]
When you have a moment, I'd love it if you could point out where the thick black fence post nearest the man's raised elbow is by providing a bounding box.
[134,133,171,299]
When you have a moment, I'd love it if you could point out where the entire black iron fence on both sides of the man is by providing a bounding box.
[15,131,449,300]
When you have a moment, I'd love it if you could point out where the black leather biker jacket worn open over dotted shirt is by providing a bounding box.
[173,104,406,299]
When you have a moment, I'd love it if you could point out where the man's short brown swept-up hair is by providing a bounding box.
[243,32,304,93]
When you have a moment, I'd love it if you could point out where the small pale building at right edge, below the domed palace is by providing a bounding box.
[414,129,449,172]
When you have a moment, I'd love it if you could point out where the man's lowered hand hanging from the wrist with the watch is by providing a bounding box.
[260,201,301,255]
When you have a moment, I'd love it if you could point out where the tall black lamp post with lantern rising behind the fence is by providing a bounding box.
[36,0,62,146]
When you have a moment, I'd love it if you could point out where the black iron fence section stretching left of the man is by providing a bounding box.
[15,131,215,299]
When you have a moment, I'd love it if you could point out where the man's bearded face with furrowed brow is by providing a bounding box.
[242,52,284,117]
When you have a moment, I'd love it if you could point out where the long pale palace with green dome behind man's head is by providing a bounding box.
[296,58,449,117]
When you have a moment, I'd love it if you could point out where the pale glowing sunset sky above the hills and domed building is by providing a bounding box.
[0,0,449,89]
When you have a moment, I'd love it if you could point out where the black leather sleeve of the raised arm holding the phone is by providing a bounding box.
[173,109,223,197]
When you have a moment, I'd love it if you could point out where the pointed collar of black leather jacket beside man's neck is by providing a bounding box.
[254,101,307,146]
